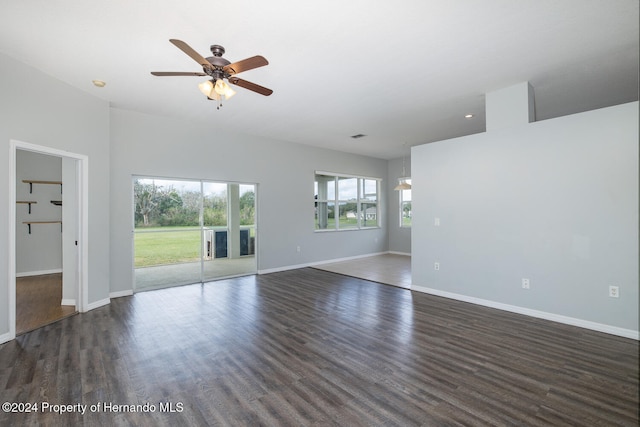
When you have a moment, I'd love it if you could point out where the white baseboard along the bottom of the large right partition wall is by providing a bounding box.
[411,285,640,340]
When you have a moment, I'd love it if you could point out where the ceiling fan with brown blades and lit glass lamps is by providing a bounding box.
[151,39,273,109]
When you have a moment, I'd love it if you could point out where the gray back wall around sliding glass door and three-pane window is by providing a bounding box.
[110,109,388,292]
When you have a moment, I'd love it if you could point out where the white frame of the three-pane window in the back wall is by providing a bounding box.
[314,171,382,233]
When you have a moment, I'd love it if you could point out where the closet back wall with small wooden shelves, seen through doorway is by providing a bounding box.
[16,150,62,276]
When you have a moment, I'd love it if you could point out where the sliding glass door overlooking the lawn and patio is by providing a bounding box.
[133,177,257,291]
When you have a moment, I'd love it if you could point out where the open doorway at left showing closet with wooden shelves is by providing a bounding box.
[9,140,88,339]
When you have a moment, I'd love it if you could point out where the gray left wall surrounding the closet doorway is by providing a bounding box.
[0,54,109,336]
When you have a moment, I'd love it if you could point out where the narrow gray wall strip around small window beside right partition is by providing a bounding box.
[386,159,413,254]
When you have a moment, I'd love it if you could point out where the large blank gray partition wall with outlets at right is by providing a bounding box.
[412,102,638,334]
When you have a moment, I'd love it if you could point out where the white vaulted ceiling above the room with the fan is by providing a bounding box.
[0,0,639,159]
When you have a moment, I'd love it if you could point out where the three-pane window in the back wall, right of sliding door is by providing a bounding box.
[314,172,380,231]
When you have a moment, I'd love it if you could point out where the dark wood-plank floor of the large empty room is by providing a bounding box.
[0,268,638,426]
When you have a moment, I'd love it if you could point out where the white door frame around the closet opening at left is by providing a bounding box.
[8,139,89,340]
